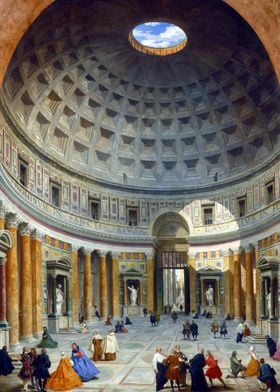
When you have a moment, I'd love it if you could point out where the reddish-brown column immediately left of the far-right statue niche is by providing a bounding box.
[245,246,255,325]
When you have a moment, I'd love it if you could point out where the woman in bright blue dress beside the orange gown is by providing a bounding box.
[71,343,100,381]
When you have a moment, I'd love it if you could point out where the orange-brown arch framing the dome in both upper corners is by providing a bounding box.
[0,0,280,85]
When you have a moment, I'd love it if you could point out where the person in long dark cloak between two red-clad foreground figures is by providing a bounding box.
[189,348,208,392]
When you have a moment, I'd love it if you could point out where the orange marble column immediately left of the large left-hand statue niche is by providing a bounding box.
[30,230,43,338]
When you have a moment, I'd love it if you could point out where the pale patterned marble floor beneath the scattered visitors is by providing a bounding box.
[0,314,280,392]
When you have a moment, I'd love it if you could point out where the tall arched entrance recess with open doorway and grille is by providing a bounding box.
[152,211,190,313]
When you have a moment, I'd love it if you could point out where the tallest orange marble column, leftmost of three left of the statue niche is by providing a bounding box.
[6,213,19,351]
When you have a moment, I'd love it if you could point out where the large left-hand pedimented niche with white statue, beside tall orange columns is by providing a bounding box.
[44,256,72,332]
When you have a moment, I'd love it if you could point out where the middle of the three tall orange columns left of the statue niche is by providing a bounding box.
[19,223,33,339]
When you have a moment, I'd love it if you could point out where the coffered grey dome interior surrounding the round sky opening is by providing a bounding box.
[3,0,280,190]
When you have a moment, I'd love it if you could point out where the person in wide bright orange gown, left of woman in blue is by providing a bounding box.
[46,352,83,391]
